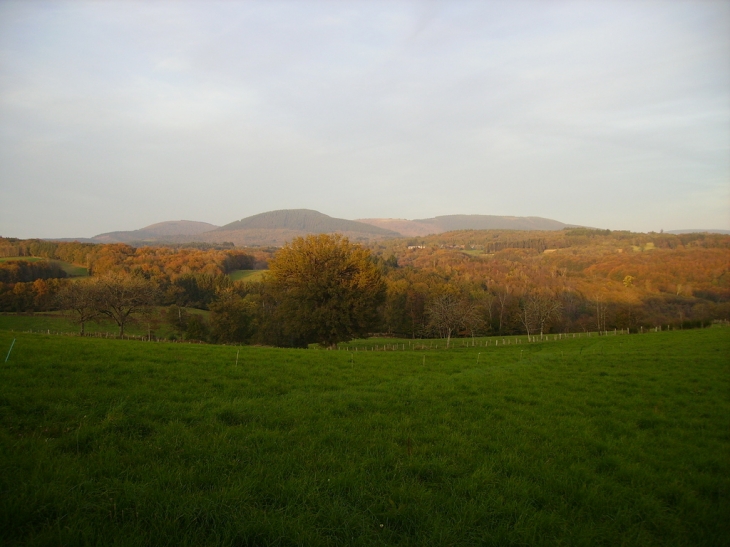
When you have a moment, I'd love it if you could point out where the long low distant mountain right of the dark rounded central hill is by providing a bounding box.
[360,215,570,236]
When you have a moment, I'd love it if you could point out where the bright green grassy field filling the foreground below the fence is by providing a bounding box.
[0,328,730,546]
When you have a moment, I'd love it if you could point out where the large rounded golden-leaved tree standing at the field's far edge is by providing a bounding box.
[269,234,385,347]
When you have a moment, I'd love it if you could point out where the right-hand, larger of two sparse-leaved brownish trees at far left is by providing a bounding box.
[96,273,157,336]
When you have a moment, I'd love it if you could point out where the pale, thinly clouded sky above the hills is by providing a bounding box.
[0,0,730,238]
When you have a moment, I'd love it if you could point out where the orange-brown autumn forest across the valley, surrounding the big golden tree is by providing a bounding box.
[0,228,730,346]
